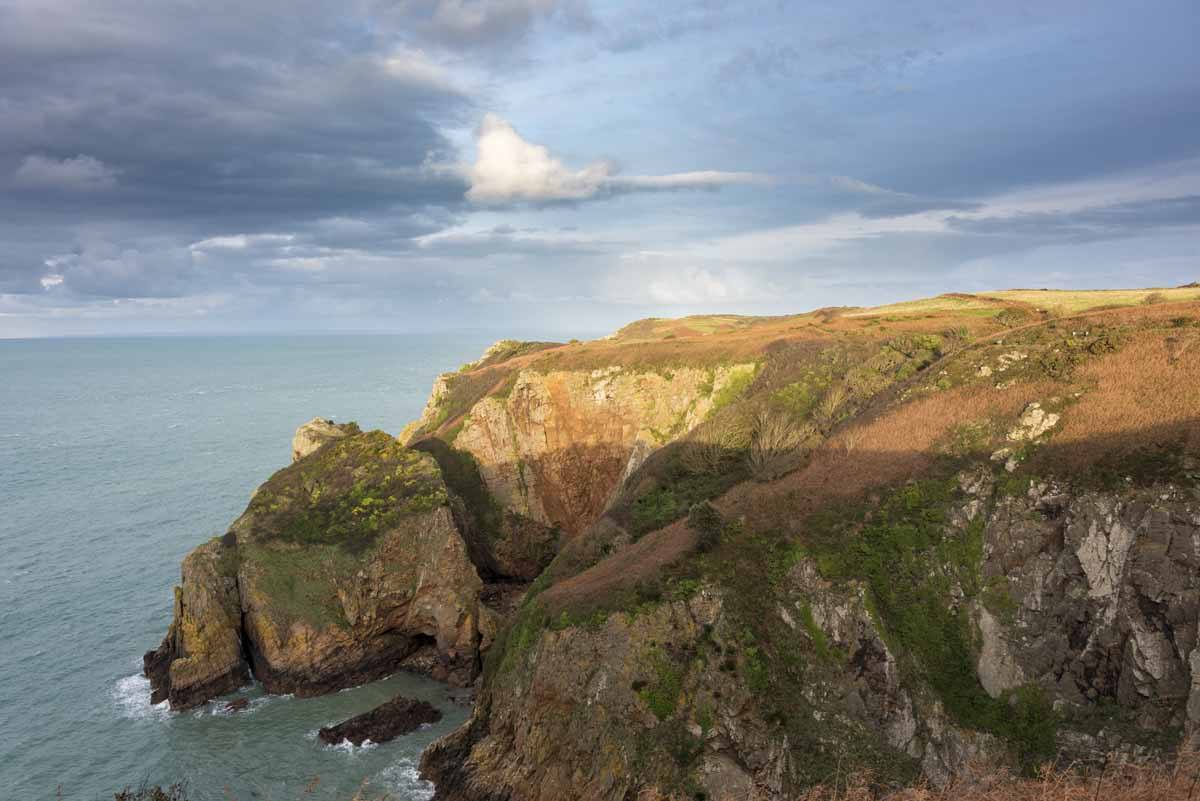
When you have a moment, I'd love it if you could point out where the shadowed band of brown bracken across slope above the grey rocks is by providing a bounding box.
[545,418,1200,602]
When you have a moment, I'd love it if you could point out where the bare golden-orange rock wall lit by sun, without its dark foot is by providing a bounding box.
[453,365,755,536]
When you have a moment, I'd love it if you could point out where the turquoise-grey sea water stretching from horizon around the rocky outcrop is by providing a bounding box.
[0,335,506,801]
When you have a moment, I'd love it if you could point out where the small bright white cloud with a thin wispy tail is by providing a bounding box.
[466,114,769,205]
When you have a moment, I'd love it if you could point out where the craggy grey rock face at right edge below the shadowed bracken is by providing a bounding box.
[979,474,1200,730]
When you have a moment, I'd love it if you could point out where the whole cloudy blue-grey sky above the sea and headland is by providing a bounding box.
[0,0,1200,337]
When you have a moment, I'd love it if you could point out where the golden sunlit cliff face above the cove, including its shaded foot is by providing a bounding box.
[400,352,756,580]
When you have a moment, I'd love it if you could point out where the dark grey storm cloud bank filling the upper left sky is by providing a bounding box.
[0,0,477,228]
